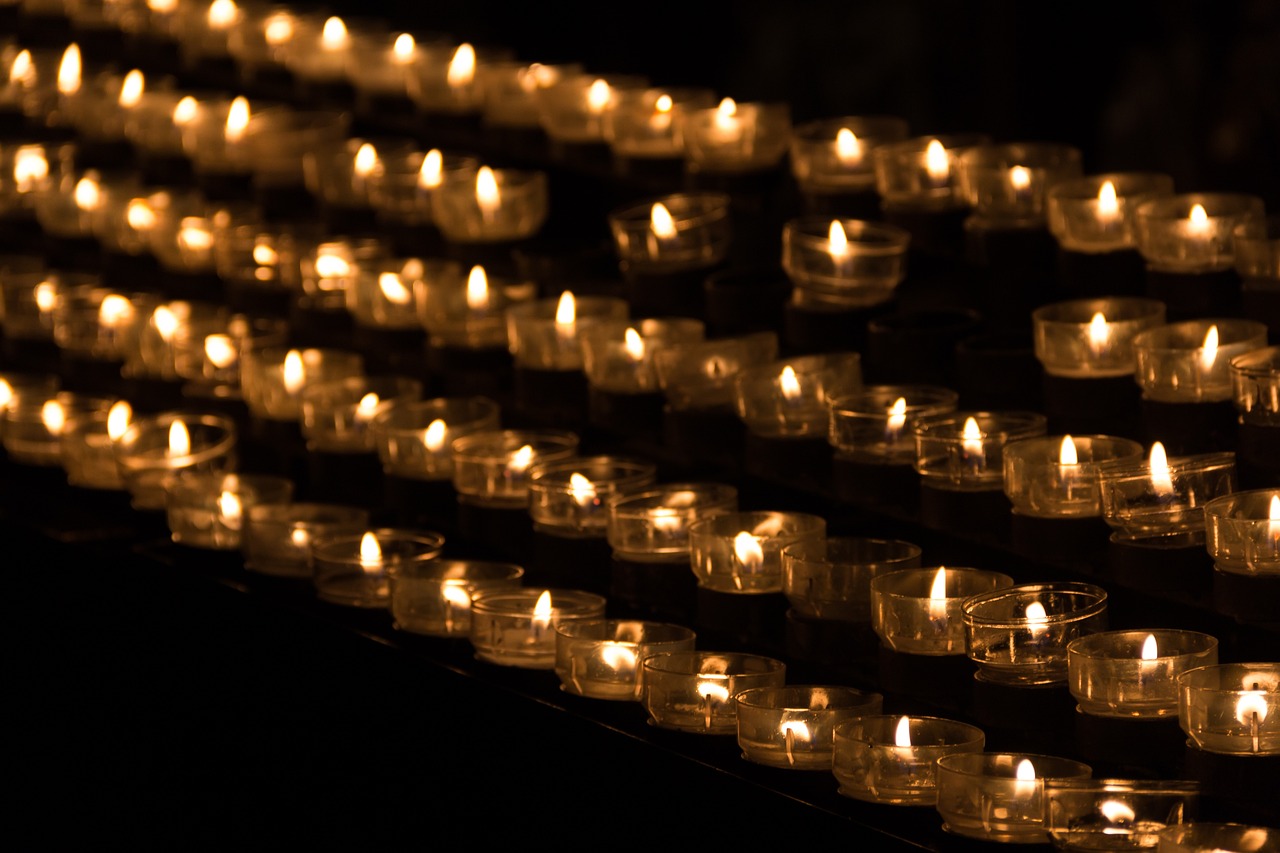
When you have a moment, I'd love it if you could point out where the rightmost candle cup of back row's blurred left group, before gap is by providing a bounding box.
[680,97,791,173]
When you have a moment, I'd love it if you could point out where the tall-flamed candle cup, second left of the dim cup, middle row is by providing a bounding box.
[507,291,627,370]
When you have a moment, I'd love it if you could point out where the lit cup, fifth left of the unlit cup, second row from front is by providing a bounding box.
[370,397,499,480]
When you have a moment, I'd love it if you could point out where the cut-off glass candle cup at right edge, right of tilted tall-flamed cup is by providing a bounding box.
[1204,489,1280,575]
